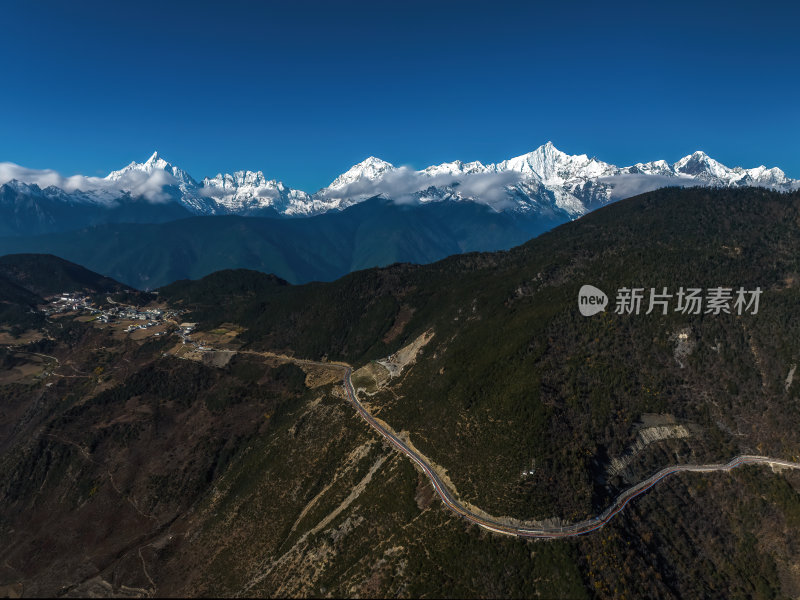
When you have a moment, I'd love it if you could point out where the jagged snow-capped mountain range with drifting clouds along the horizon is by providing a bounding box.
[0,142,800,218]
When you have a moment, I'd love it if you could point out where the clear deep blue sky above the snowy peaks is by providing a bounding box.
[0,0,800,191]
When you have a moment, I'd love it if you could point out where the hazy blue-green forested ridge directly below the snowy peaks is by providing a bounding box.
[0,198,568,289]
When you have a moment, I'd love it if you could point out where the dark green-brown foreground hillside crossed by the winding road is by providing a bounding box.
[0,189,800,598]
